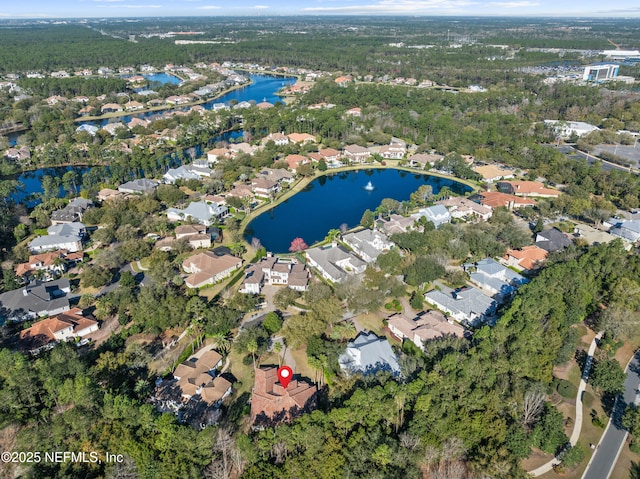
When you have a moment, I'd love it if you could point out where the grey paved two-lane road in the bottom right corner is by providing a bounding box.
[582,353,640,479]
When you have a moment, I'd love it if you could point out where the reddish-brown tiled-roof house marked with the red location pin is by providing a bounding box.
[251,366,318,429]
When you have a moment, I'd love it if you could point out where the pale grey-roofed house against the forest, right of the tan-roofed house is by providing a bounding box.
[424,286,497,326]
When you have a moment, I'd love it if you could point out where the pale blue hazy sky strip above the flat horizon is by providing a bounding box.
[0,0,640,19]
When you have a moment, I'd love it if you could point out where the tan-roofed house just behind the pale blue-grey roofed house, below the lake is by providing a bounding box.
[387,310,467,351]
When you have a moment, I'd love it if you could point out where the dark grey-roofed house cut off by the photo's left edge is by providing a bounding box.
[0,278,71,324]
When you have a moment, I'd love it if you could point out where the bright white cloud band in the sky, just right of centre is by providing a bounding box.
[302,0,478,14]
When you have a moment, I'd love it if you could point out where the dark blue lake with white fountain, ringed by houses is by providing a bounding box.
[245,169,470,253]
